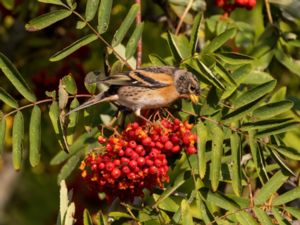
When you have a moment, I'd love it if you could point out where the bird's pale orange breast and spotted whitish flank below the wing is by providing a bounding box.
[118,86,179,110]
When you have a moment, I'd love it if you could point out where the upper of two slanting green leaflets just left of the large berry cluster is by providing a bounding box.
[50,128,98,165]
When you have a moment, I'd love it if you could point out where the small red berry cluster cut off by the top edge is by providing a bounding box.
[215,0,256,12]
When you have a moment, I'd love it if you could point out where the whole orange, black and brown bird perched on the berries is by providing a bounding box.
[67,66,200,116]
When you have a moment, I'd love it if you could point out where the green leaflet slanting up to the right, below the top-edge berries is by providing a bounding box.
[202,28,236,53]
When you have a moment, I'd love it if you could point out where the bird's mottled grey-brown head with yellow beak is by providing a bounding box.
[174,69,200,103]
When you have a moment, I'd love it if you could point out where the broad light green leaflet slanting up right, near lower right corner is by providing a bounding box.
[254,171,288,205]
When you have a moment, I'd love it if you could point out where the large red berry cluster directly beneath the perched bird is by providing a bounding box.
[80,119,196,201]
